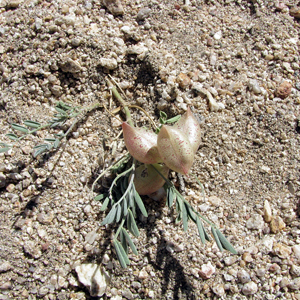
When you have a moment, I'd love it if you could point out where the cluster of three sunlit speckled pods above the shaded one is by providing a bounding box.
[122,108,201,195]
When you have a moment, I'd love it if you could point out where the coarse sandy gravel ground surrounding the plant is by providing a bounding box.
[0,0,300,300]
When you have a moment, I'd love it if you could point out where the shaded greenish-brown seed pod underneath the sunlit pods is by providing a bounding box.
[133,164,169,195]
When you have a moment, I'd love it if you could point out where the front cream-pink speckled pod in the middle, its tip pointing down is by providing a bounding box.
[157,125,195,175]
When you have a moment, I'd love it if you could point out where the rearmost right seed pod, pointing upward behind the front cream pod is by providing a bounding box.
[173,107,201,153]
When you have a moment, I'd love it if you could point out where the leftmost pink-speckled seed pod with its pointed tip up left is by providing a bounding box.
[122,122,161,164]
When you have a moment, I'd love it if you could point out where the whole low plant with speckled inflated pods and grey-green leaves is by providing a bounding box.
[0,80,236,268]
